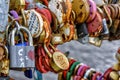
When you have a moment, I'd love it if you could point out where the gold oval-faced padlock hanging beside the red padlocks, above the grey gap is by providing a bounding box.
[50,44,69,72]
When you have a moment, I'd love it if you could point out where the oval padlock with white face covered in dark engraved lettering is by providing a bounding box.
[24,9,43,38]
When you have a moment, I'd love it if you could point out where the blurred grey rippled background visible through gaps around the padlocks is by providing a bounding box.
[10,41,120,80]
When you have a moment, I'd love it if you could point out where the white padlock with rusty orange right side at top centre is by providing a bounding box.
[48,0,72,24]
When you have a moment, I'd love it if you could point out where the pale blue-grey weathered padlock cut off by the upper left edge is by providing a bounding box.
[0,0,10,43]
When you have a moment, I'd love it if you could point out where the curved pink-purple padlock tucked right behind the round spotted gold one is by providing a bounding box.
[86,0,97,23]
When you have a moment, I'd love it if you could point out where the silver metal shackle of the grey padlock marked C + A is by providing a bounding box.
[10,26,33,46]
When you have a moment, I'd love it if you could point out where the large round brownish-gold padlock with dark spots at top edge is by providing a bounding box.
[72,0,90,23]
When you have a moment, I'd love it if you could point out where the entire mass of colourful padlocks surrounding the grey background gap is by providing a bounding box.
[0,0,120,80]
